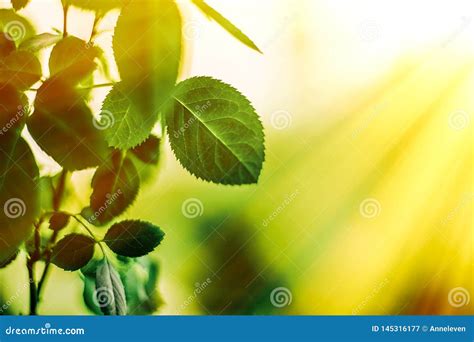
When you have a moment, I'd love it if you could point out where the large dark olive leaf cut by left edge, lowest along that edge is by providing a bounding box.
[0,131,39,260]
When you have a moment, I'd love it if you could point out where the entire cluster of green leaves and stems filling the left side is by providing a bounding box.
[0,0,264,315]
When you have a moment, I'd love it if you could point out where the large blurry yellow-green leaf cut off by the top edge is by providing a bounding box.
[113,0,181,118]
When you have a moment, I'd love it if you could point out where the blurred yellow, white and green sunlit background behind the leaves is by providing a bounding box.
[0,0,474,315]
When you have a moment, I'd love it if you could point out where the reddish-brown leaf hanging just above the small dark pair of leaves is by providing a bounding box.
[88,154,140,224]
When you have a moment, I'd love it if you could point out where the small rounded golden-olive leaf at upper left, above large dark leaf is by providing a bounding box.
[49,36,98,84]
